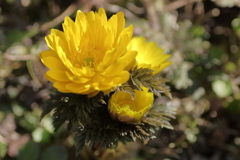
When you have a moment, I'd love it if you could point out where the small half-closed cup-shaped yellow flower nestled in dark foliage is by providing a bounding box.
[108,87,154,123]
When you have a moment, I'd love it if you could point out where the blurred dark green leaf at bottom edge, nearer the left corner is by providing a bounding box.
[18,141,40,160]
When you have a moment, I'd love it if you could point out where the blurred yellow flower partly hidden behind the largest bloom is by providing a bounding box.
[128,37,172,74]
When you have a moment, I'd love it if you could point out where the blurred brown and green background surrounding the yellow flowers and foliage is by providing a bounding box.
[0,0,240,160]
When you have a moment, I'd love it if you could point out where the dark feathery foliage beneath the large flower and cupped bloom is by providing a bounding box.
[41,90,175,155]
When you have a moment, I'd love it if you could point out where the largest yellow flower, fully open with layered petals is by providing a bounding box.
[40,8,137,95]
